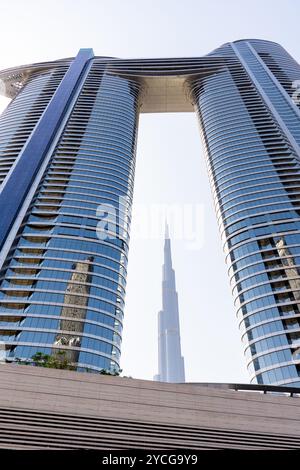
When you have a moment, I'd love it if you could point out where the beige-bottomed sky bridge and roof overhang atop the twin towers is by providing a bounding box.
[0,56,228,113]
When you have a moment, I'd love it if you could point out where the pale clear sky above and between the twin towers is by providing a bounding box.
[0,0,300,382]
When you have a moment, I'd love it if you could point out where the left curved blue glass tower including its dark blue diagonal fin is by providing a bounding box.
[0,50,140,370]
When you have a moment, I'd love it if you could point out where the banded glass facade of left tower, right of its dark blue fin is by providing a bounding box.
[0,54,140,370]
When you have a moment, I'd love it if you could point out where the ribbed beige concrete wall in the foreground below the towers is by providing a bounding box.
[0,365,300,449]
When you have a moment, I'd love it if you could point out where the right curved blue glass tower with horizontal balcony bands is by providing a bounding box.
[191,40,300,386]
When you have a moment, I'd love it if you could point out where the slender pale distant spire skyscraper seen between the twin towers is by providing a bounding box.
[154,224,185,383]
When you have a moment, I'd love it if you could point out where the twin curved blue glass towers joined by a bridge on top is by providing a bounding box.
[0,39,300,386]
